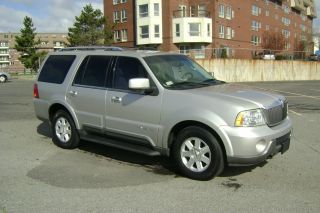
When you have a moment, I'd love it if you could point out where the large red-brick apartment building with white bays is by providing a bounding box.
[104,0,316,58]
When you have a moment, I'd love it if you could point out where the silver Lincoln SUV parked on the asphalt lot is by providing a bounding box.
[34,48,292,180]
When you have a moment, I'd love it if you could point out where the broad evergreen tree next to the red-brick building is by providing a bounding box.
[68,4,113,46]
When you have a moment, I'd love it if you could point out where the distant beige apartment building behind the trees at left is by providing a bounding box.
[0,33,67,72]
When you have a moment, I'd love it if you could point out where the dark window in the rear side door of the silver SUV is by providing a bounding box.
[74,56,111,87]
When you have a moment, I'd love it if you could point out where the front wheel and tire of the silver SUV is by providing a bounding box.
[172,126,224,180]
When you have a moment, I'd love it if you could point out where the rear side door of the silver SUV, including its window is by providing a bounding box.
[67,55,112,132]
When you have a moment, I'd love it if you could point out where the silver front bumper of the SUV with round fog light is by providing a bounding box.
[223,118,292,166]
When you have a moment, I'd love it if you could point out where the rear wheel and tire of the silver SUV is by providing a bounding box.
[51,110,80,149]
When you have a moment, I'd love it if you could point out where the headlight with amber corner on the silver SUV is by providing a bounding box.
[234,109,266,127]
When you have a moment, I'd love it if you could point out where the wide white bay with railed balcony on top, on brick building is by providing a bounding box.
[172,10,212,43]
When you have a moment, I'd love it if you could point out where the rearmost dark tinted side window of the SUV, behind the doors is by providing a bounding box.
[38,55,76,84]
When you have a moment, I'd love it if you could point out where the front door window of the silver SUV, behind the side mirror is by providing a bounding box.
[113,57,148,90]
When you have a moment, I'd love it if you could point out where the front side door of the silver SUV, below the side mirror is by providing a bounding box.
[106,57,161,146]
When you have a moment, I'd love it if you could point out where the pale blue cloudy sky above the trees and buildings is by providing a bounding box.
[0,0,320,32]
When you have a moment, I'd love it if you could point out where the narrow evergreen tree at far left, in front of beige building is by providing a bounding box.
[15,16,45,70]
